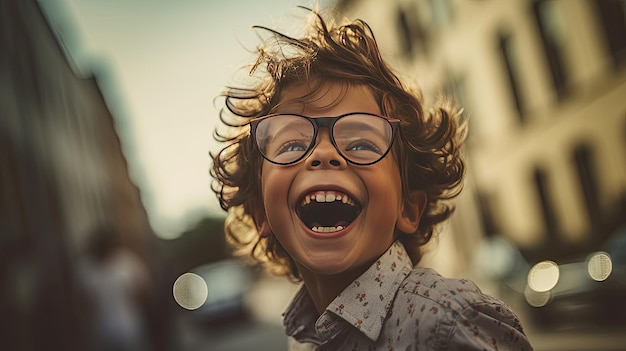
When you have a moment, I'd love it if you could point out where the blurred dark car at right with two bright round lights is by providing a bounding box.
[524,226,626,327]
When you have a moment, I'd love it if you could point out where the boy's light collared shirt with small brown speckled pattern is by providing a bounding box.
[283,242,532,351]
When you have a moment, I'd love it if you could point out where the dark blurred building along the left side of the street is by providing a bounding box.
[0,0,172,350]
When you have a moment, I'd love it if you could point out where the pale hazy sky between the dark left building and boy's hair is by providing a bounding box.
[40,0,331,237]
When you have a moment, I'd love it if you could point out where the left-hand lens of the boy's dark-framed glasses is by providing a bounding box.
[255,115,314,164]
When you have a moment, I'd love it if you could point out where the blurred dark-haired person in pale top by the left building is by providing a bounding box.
[78,224,152,351]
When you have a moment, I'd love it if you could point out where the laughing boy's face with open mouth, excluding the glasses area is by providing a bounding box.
[261,83,410,275]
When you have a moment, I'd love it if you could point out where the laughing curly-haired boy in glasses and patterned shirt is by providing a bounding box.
[211,6,531,350]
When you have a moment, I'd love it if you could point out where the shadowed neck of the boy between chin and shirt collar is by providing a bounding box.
[298,262,371,315]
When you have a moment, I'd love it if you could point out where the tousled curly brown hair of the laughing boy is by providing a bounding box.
[211,10,466,281]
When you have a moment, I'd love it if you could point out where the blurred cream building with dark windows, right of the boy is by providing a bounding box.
[338,0,626,274]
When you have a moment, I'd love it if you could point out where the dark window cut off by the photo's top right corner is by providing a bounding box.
[591,0,626,68]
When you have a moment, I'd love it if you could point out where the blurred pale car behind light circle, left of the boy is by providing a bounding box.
[191,258,253,322]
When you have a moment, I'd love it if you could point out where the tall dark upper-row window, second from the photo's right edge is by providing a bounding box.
[533,0,568,100]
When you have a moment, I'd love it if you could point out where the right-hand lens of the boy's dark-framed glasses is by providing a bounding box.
[333,114,393,164]
